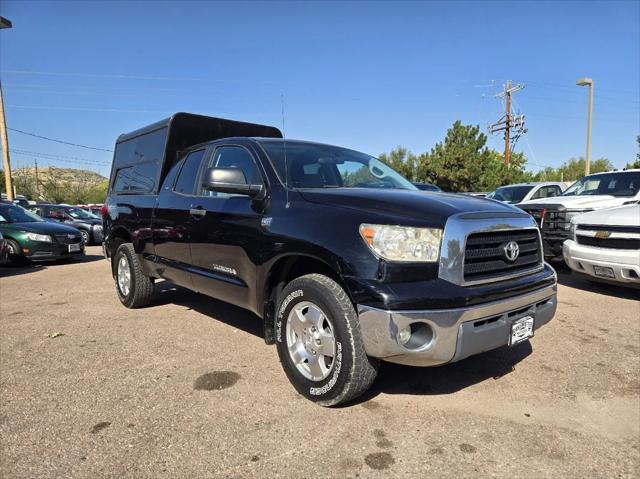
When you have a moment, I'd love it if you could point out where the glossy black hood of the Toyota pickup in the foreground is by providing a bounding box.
[299,188,522,224]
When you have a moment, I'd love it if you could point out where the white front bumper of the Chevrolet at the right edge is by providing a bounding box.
[562,240,640,286]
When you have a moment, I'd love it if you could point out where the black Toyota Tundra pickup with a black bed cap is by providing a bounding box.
[103,113,556,406]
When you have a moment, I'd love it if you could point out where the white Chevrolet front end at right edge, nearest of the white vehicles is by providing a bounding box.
[562,205,640,287]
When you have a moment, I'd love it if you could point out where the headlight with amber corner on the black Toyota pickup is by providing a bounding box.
[360,224,442,263]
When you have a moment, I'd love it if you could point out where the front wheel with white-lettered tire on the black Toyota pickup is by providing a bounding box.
[275,274,378,406]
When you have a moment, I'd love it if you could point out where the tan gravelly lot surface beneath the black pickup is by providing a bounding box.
[0,247,640,478]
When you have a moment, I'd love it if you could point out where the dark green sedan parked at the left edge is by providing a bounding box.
[0,203,84,263]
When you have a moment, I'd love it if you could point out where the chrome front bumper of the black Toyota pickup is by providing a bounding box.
[358,285,557,366]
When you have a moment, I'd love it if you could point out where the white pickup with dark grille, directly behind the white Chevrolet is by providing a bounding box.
[518,169,640,259]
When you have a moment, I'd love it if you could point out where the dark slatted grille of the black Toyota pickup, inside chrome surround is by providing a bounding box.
[464,230,542,281]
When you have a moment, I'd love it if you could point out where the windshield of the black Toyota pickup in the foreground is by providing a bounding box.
[260,140,417,191]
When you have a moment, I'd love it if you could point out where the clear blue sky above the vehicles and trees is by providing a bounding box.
[0,0,640,178]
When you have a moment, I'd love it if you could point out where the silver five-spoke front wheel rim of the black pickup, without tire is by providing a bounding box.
[286,301,336,381]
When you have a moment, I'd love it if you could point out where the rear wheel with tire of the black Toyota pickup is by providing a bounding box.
[113,243,153,309]
